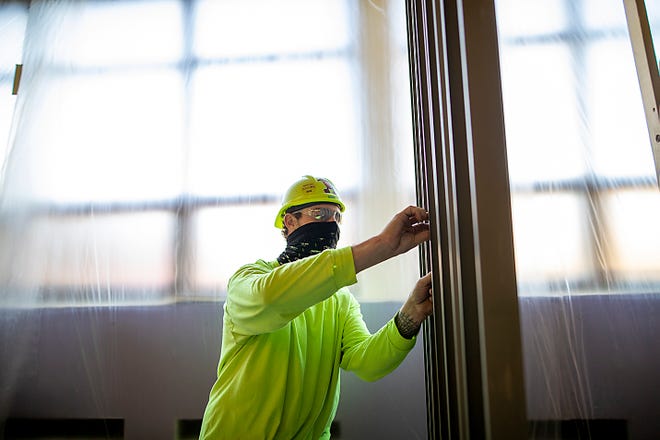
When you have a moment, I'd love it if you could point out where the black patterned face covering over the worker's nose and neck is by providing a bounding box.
[277,222,339,264]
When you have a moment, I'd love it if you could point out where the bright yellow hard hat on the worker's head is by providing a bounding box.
[275,176,346,229]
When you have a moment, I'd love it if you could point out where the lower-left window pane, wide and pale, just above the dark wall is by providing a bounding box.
[0,212,174,306]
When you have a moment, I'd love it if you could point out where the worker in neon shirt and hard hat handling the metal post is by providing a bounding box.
[200,176,433,440]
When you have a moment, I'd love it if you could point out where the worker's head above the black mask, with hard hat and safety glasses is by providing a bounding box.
[275,176,346,237]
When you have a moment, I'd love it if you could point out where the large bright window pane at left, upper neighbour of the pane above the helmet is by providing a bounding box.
[9,71,182,203]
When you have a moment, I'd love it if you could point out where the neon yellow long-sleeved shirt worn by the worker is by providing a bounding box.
[200,247,415,440]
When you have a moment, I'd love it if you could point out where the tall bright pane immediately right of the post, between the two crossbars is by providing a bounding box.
[502,43,585,185]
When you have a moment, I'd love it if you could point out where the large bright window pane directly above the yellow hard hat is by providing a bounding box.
[189,58,360,195]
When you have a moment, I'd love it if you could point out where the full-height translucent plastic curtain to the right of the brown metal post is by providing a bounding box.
[496,0,660,439]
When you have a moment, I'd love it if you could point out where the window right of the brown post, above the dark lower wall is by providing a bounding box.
[497,0,660,295]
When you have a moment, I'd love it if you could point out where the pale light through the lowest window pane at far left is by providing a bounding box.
[3,212,174,295]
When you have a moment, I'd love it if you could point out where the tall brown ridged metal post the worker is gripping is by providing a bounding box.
[407,0,526,439]
